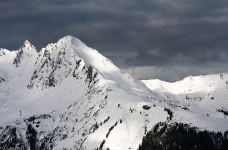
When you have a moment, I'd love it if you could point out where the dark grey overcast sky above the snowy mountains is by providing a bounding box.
[0,0,228,82]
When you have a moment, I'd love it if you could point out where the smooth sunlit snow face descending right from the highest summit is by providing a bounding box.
[57,35,139,86]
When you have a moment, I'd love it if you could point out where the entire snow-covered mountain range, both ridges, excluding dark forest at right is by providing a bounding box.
[0,36,228,150]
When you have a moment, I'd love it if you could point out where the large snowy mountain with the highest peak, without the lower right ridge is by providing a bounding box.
[0,36,168,149]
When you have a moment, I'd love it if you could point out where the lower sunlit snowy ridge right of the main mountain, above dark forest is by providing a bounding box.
[142,73,228,131]
